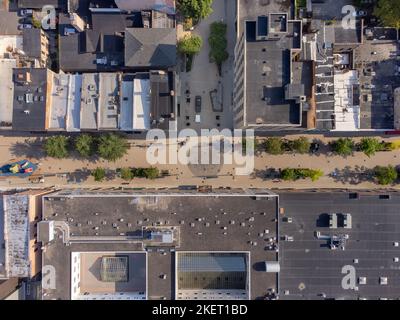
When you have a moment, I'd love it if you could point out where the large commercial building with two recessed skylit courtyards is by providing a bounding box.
[38,190,278,300]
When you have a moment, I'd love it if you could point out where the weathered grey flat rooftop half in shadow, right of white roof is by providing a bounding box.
[355,28,400,129]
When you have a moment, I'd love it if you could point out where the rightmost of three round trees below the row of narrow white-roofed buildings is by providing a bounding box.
[97,133,129,161]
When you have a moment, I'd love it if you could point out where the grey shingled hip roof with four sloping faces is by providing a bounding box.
[125,28,176,68]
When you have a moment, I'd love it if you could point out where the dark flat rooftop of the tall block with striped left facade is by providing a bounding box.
[245,14,304,125]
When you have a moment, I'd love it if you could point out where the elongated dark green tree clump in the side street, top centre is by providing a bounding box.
[208,22,229,75]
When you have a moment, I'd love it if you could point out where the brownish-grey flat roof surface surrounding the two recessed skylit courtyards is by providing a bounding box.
[43,191,277,299]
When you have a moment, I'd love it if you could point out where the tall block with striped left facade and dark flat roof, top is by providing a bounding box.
[234,3,311,129]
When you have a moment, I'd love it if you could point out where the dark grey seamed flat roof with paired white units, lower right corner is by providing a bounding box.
[280,192,400,299]
